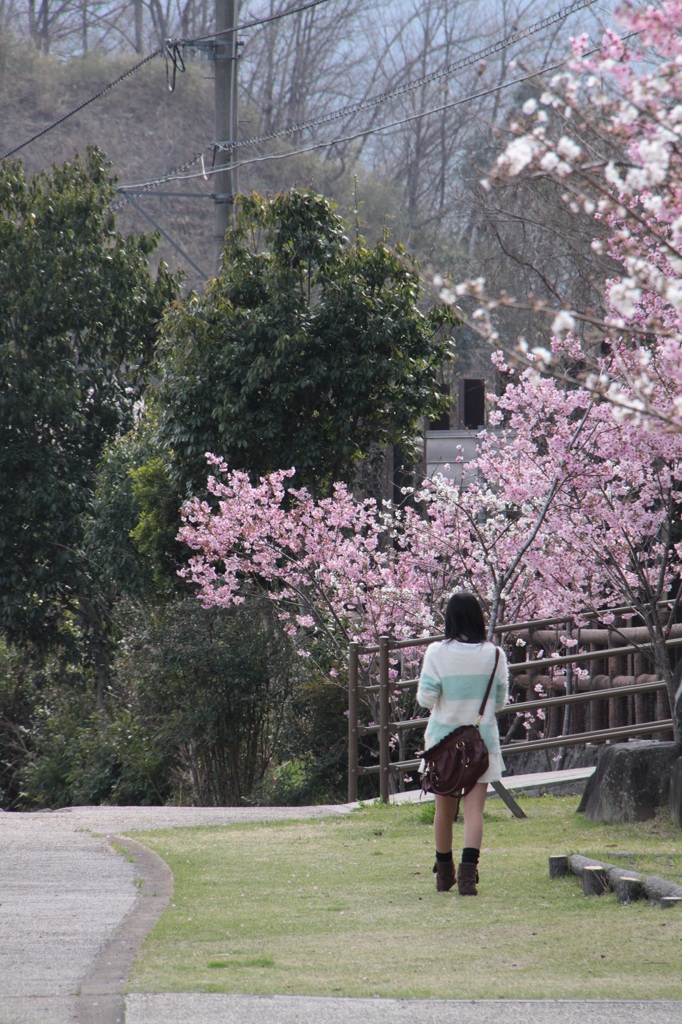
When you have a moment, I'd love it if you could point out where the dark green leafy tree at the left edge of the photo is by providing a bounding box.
[0,150,177,645]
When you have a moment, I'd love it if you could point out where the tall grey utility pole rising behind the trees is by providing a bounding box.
[213,0,240,274]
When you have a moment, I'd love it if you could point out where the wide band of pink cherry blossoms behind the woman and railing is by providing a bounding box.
[180,346,682,737]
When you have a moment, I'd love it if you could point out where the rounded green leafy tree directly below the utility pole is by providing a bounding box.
[156,189,452,494]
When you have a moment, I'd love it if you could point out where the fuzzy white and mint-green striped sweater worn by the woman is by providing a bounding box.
[417,640,509,755]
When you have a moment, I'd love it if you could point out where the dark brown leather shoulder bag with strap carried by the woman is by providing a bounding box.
[422,650,500,798]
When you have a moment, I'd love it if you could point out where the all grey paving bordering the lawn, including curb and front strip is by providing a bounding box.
[0,806,682,1024]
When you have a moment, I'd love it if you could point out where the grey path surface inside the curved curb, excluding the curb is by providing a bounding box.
[0,814,136,1024]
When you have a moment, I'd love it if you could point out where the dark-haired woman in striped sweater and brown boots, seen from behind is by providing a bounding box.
[417,591,509,896]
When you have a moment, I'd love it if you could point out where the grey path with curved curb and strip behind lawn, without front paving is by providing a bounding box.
[0,806,349,1024]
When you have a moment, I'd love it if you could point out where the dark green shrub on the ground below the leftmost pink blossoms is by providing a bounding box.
[115,598,300,805]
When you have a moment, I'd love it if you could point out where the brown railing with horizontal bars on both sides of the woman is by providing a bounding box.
[348,609,682,802]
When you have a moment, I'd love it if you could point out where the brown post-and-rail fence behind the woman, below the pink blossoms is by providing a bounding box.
[348,609,682,802]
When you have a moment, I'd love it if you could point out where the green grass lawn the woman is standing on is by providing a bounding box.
[129,797,682,999]
